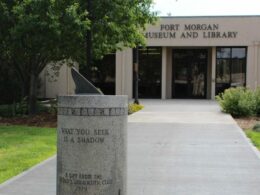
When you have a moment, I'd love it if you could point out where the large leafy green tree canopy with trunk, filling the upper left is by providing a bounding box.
[0,0,155,114]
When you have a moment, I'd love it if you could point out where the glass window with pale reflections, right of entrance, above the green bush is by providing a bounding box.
[216,47,247,94]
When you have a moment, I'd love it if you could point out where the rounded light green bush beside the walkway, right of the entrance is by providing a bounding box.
[216,87,257,117]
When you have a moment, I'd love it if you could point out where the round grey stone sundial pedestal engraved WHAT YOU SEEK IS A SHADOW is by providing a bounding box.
[57,95,128,195]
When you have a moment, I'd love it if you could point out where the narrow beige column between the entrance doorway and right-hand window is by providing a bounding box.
[211,47,217,100]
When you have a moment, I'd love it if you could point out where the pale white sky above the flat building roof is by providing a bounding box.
[153,0,260,16]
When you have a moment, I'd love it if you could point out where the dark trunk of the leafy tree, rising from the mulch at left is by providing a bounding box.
[28,72,37,116]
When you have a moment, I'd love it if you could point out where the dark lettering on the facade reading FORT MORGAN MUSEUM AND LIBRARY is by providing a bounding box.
[145,24,238,39]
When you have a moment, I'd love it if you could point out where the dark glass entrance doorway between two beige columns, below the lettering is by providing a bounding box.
[172,49,208,99]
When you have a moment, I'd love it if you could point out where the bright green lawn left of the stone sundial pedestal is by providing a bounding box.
[0,126,56,183]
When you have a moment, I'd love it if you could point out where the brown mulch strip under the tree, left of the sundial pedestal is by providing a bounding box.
[0,113,57,127]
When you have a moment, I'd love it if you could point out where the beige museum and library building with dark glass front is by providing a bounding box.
[42,16,260,99]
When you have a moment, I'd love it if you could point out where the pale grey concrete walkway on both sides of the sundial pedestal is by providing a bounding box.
[0,100,260,195]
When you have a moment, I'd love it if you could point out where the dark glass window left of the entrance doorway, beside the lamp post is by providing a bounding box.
[133,47,162,98]
